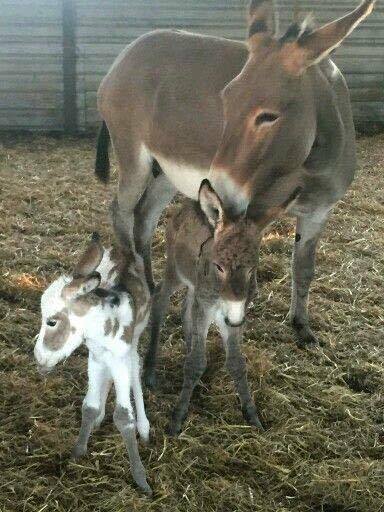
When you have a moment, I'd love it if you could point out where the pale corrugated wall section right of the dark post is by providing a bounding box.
[76,0,384,129]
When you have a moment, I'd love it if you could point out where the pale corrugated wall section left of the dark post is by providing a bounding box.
[0,0,63,130]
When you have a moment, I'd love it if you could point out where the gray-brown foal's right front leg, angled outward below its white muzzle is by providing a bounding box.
[216,316,264,430]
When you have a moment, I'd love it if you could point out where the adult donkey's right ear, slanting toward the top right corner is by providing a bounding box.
[281,0,376,75]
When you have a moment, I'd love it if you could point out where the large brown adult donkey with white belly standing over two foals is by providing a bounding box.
[96,0,375,345]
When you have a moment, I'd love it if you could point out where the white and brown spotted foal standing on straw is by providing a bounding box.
[35,230,151,494]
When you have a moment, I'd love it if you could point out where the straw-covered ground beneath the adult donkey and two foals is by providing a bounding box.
[0,135,384,512]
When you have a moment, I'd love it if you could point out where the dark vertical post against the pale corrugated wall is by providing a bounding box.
[62,0,77,135]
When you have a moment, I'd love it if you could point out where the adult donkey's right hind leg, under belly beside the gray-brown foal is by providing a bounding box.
[135,173,176,293]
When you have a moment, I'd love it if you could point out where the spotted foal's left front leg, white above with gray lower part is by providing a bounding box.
[72,352,110,457]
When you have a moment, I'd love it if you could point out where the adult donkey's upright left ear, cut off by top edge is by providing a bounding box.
[248,0,278,44]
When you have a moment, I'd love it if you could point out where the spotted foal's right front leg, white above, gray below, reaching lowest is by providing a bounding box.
[110,359,152,494]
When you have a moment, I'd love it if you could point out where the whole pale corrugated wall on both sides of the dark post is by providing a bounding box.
[0,0,384,130]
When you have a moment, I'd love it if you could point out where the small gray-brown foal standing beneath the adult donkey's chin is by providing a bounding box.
[144,180,297,435]
